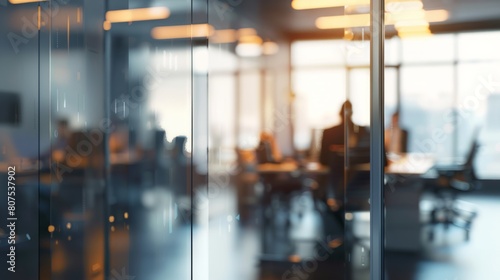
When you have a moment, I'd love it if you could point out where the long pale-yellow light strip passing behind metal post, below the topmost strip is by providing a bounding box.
[316,10,449,29]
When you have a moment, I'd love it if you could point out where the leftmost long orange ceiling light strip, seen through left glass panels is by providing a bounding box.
[106,7,170,23]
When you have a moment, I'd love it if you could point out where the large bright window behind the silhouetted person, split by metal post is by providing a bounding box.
[291,32,500,164]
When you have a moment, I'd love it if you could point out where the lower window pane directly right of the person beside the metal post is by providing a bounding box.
[400,66,454,158]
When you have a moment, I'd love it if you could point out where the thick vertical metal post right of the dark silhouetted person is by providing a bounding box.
[370,0,385,280]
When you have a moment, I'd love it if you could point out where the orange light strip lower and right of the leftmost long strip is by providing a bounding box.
[151,24,214,40]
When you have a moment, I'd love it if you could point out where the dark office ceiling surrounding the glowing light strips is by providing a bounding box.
[80,0,500,40]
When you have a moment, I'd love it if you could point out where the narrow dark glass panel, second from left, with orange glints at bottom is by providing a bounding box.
[43,1,109,279]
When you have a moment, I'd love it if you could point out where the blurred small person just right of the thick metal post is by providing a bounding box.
[384,112,408,154]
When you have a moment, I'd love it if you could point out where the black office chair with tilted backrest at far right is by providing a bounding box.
[429,140,479,241]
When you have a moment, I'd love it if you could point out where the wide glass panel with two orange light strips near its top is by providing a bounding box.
[105,0,195,279]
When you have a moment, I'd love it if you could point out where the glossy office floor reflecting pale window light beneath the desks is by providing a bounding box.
[43,180,500,280]
